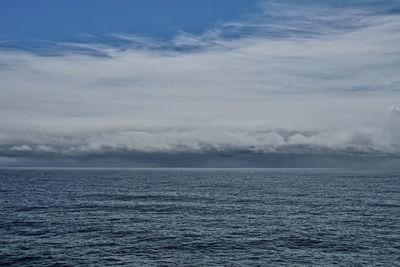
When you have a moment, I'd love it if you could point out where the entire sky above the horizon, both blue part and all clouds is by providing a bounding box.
[0,0,400,167]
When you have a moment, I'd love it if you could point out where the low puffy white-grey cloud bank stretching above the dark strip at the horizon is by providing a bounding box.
[0,128,400,157]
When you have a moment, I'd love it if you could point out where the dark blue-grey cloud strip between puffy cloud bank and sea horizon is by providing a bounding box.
[0,151,400,168]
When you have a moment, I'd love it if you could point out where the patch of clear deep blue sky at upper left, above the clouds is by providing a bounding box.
[0,0,258,42]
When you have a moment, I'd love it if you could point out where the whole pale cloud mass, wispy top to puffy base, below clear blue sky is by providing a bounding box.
[0,3,400,165]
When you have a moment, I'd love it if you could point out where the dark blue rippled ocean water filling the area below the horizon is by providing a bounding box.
[0,169,400,266]
